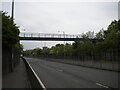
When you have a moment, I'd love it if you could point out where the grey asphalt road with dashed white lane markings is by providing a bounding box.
[26,58,118,88]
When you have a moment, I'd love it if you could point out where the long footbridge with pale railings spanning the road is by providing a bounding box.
[19,33,101,41]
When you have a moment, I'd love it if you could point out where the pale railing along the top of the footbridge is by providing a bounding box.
[19,32,82,38]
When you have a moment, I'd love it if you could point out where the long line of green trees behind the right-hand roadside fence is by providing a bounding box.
[23,20,120,60]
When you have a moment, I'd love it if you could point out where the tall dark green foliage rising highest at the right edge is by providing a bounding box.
[96,20,120,51]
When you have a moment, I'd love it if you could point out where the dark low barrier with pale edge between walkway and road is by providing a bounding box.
[21,57,46,90]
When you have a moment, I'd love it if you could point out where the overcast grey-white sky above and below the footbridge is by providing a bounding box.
[2,0,118,49]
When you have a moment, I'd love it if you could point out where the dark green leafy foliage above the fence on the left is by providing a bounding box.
[0,12,19,46]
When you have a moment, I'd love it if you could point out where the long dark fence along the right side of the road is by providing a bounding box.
[26,52,120,71]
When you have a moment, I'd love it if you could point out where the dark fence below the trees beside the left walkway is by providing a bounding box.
[2,46,20,75]
